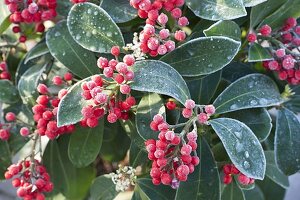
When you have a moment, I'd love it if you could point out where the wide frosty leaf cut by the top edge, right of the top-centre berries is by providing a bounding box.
[186,0,247,21]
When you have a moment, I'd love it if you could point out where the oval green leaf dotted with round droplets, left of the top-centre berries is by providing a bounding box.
[68,3,125,53]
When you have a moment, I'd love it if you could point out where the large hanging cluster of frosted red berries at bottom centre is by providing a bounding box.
[145,114,199,189]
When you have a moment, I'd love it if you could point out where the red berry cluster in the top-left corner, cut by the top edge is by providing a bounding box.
[4,0,57,42]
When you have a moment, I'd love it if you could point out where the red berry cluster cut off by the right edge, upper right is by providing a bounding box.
[248,18,300,85]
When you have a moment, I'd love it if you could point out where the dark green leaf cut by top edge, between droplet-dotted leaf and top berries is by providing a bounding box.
[100,0,137,23]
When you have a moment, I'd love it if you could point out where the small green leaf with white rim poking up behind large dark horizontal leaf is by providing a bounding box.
[203,20,241,41]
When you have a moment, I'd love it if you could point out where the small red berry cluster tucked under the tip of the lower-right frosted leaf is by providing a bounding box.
[223,164,255,185]
